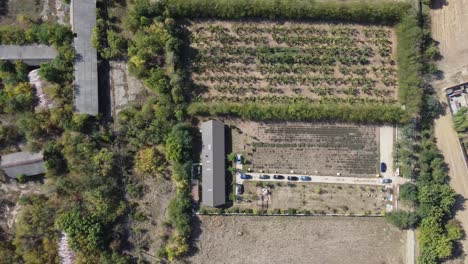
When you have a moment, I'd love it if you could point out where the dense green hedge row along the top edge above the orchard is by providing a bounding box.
[168,0,410,24]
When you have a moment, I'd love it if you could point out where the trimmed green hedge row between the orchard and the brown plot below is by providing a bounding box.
[188,103,408,123]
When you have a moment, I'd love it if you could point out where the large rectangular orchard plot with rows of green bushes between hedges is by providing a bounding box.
[189,21,397,103]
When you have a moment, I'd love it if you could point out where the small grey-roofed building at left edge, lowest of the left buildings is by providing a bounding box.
[0,152,46,178]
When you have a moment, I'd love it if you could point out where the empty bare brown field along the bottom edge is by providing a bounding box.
[183,216,406,264]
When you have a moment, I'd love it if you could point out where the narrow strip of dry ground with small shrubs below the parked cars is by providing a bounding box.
[235,181,391,214]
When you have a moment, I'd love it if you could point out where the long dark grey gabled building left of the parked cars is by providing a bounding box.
[201,120,226,207]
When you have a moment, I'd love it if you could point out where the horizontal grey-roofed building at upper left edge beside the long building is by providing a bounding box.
[0,45,58,66]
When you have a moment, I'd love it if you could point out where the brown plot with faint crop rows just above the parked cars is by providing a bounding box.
[225,119,379,177]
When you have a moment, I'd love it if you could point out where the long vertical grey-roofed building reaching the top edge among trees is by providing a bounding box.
[70,0,99,115]
